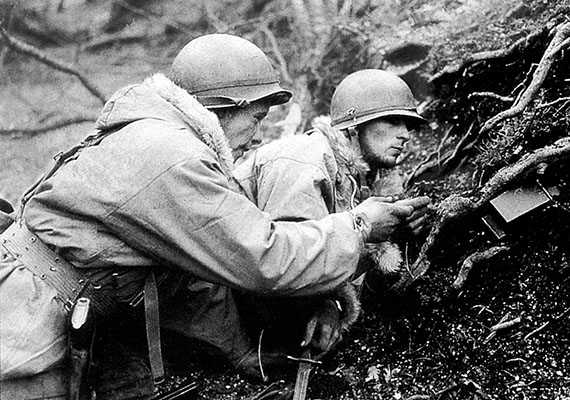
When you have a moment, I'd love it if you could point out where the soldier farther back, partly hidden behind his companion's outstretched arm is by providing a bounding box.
[234,69,429,362]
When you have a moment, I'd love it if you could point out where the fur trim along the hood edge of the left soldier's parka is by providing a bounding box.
[143,74,234,174]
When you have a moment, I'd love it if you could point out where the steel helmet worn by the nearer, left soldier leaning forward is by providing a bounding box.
[170,34,291,108]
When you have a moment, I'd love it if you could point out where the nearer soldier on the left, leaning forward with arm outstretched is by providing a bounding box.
[0,34,413,399]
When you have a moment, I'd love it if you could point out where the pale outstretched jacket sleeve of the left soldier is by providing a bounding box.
[100,152,363,295]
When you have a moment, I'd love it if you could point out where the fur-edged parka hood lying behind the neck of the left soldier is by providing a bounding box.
[95,74,233,170]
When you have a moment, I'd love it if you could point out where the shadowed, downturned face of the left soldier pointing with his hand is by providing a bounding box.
[219,102,269,159]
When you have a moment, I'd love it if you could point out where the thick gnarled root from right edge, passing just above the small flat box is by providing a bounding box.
[391,138,570,294]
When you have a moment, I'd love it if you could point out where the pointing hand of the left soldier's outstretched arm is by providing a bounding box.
[351,197,414,242]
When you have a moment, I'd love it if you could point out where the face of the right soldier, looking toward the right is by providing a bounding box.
[358,117,411,168]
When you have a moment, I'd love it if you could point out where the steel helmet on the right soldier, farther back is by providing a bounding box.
[330,69,426,129]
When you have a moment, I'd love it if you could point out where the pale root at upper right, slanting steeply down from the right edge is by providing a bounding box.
[479,23,570,135]
